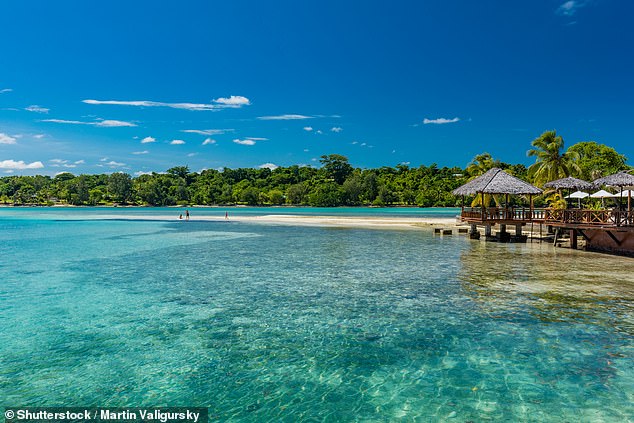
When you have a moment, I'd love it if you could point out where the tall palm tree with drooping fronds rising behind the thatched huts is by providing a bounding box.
[527,131,581,186]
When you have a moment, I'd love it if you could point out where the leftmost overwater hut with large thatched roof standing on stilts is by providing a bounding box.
[453,168,543,241]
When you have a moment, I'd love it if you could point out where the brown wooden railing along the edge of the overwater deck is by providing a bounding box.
[460,207,634,227]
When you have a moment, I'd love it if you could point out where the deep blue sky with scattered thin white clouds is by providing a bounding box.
[0,0,634,175]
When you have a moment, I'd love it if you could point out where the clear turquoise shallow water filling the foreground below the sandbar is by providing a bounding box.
[0,209,634,422]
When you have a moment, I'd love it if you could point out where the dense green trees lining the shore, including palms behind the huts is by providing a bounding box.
[0,135,628,207]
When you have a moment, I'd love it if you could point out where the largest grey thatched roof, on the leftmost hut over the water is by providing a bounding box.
[453,167,542,195]
